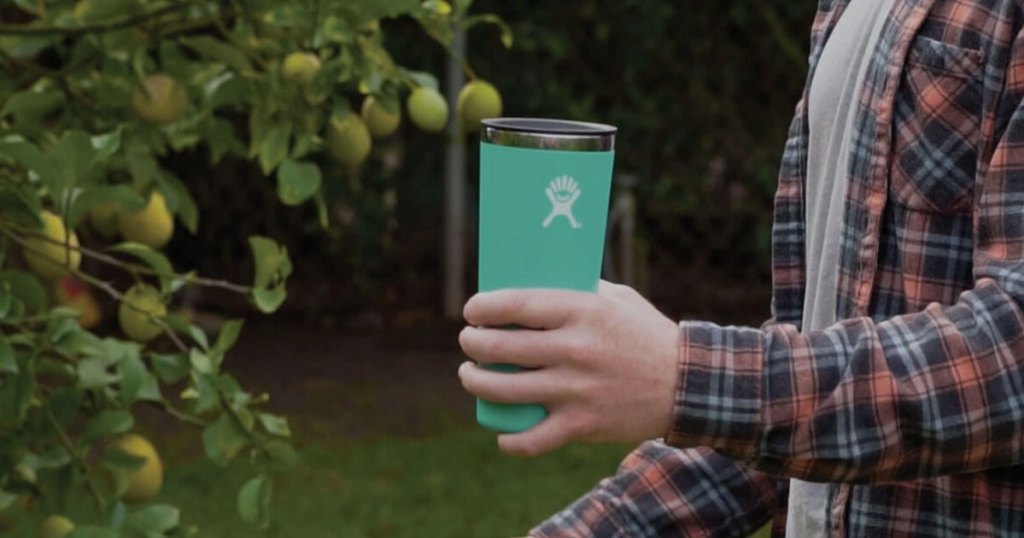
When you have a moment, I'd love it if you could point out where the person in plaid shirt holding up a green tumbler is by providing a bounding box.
[459,0,1024,538]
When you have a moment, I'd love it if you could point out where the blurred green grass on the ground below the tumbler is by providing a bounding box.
[11,428,628,538]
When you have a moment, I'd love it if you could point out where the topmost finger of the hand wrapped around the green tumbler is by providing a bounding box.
[463,289,594,329]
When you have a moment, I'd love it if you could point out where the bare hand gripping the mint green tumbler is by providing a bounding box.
[459,281,679,456]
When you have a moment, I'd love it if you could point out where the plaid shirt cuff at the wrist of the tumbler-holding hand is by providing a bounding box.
[665,322,766,461]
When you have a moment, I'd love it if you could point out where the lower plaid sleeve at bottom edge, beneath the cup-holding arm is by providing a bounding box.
[530,442,788,538]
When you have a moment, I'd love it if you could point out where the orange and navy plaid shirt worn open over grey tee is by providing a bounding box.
[534,0,1024,538]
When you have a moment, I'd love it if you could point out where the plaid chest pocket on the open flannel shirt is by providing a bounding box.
[889,36,983,213]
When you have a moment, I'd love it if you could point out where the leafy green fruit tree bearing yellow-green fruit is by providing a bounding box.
[0,0,511,537]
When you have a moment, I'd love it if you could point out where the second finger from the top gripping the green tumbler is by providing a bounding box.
[459,327,561,368]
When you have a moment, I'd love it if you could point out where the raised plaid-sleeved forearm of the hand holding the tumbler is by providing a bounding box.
[667,281,1024,482]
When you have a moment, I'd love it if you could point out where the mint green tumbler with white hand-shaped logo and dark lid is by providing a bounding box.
[476,118,616,432]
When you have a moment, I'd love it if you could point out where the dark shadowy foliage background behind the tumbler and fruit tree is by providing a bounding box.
[175,0,814,323]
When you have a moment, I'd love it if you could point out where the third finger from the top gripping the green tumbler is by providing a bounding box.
[459,362,554,404]
